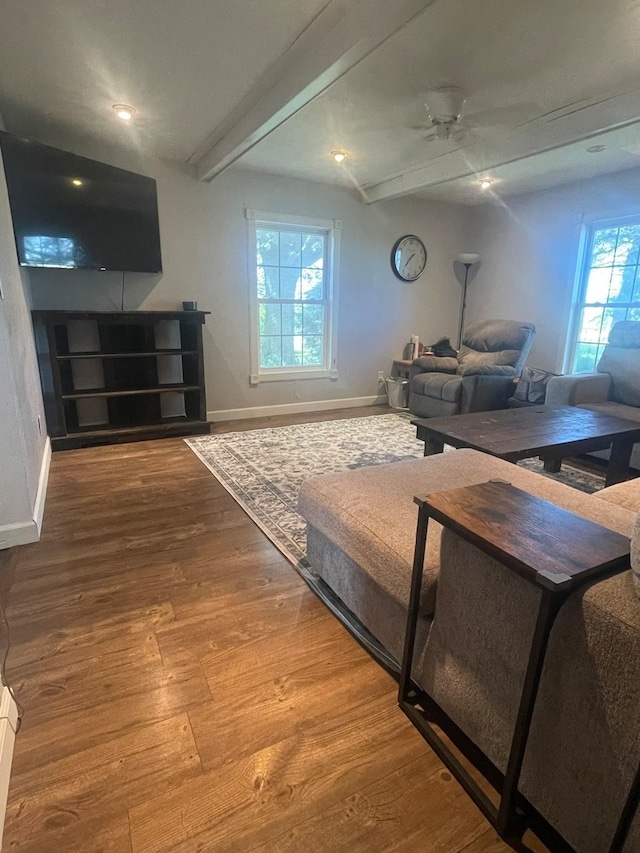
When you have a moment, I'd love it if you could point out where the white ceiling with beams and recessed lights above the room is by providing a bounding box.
[0,0,640,203]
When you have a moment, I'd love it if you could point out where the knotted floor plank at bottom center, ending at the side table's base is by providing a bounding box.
[129,696,435,853]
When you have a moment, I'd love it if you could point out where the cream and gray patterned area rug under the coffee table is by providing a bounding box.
[185,413,604,575]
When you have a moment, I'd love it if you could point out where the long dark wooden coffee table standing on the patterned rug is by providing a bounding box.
[411,406,640,486]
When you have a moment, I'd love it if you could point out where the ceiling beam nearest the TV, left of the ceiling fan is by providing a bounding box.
[189,0,437,181]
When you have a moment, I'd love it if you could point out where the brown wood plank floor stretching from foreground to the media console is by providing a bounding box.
[0,409,542,853]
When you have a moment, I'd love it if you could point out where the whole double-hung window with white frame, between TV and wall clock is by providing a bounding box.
[247,210,340,383]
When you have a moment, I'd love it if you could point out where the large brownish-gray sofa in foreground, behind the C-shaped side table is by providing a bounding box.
[299,450,640,853]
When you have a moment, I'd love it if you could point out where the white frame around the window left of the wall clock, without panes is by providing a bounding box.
[245,209,342,385]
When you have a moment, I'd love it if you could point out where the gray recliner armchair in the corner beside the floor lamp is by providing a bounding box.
[409,320,535,418]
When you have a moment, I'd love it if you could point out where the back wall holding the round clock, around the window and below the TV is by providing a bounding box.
[25,133,472,418]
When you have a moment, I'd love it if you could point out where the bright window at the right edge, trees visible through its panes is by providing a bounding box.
[572,220,640,373]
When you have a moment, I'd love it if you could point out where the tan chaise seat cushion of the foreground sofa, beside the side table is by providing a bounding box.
[298,449,633,613]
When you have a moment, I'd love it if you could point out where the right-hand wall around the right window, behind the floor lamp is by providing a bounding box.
[467,169,640,373]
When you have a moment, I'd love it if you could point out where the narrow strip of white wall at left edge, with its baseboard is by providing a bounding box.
[0,146,48,548]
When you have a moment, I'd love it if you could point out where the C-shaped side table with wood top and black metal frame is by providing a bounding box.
[398,480,632,853]
